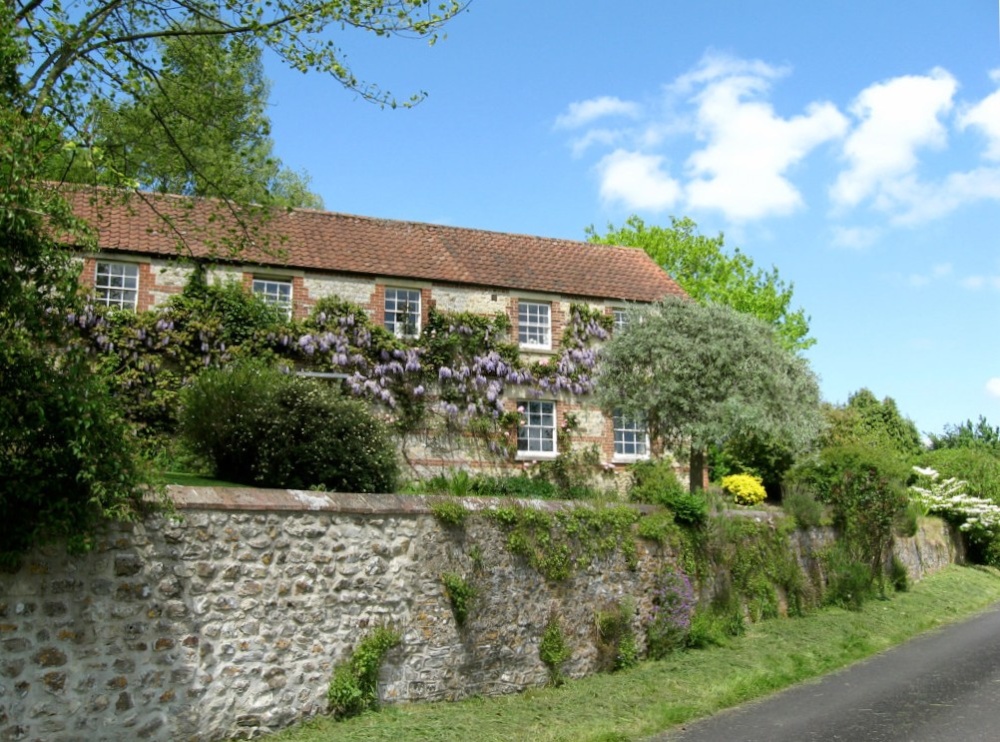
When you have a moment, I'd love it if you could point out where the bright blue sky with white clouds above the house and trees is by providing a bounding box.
[267,0,1000,433]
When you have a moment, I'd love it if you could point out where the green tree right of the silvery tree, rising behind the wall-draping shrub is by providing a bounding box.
[822,389,924,460]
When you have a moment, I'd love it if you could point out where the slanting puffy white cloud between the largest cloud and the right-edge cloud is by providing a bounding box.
[830,68,958,209]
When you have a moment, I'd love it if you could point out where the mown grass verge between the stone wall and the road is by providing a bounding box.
[269,567,1000,742]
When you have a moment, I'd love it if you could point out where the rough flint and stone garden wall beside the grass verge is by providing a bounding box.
[0,488,968,742]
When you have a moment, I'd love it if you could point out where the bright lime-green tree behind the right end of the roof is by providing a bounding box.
[587,216,816,351]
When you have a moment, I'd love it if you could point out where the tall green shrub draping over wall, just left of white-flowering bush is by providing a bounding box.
[794,446,909,590]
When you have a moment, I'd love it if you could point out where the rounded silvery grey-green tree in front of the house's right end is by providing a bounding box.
[597,297,821,489]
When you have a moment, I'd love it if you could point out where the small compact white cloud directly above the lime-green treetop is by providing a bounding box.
[597,149,681,211]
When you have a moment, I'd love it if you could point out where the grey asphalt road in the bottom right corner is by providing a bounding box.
[655,604,1000,742]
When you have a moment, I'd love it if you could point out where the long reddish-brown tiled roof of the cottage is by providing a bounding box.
[68,189,684,302]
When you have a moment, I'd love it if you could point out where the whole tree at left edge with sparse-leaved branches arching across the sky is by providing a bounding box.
[0,0,462,557]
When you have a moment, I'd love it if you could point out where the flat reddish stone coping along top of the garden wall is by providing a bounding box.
[167,485,657,515]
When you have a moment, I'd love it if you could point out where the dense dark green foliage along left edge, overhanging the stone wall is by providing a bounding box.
[0,36,148,566]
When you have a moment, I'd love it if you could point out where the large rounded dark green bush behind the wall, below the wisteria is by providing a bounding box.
[181,363,398,492]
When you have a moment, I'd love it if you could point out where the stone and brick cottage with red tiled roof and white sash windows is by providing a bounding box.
[64,191,683,480]
